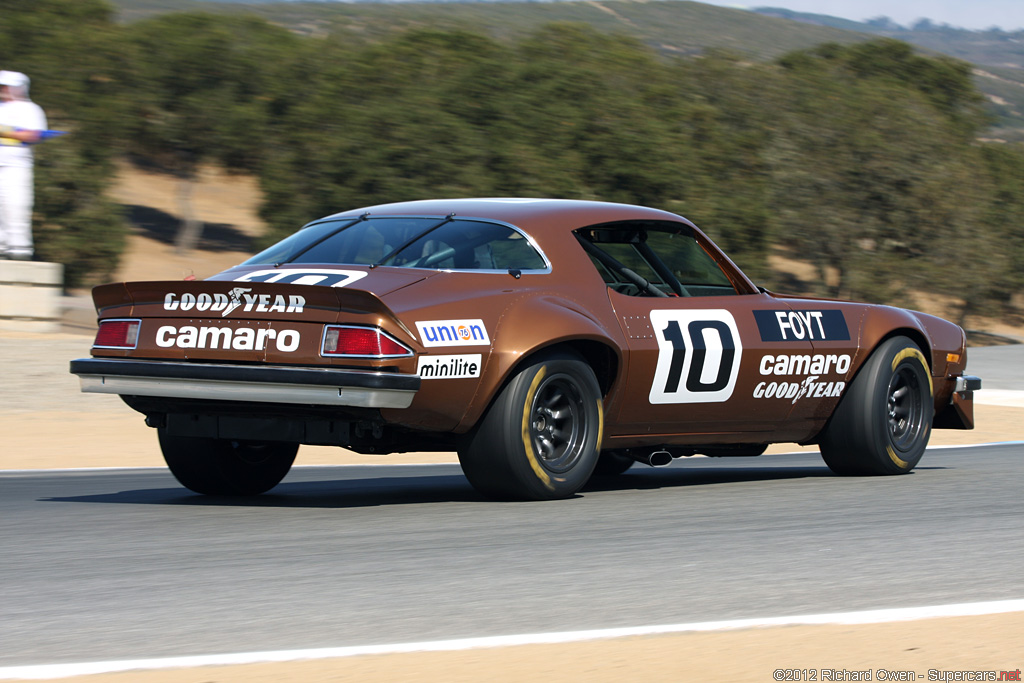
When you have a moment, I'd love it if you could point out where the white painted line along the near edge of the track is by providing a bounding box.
[0,600,1024,680]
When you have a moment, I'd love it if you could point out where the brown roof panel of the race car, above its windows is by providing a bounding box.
[322,198,692,230]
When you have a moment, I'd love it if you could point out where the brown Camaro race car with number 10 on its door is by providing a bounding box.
[71,199,981,499]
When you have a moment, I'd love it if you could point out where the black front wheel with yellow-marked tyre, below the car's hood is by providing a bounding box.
[820,337,935,474]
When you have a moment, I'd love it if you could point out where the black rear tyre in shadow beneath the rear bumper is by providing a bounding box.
[157,427,299,496]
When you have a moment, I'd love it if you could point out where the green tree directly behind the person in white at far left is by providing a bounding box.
[0,0,129,287]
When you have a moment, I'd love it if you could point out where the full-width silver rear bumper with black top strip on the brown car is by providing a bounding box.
[71,358,420,409]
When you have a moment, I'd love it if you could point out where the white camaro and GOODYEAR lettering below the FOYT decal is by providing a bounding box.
[754,353,852,403]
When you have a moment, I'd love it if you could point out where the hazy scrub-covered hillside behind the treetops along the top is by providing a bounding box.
[101,0,1024,140]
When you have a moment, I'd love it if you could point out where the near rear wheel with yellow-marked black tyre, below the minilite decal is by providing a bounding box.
[459,353,603,500]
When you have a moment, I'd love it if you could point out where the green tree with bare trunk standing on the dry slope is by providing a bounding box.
[127,13,298,251]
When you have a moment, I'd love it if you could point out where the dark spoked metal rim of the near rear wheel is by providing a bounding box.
[529,375,586,473]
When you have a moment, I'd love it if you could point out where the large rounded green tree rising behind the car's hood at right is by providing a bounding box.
[770,41,984,301]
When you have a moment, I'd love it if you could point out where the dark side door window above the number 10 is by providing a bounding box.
[577,222,736,297]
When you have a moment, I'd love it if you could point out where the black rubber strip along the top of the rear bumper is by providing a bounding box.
[71,358,420,391]
